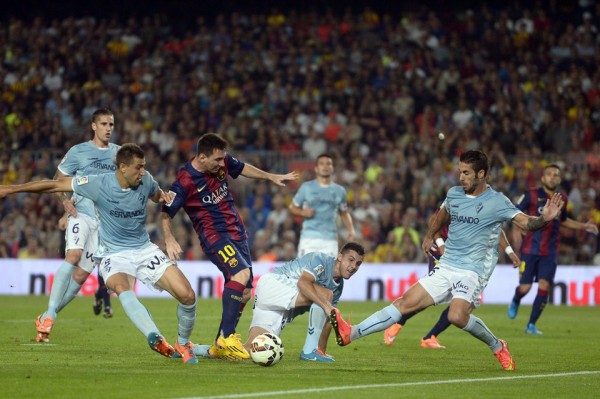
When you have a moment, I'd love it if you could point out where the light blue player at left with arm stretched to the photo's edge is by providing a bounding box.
[0,144,198,363]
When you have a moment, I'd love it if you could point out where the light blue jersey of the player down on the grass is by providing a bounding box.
[269,252,344,304]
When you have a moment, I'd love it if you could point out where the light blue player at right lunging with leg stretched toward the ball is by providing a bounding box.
[330,150,564,370]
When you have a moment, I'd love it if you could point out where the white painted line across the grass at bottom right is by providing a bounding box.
[173,370,600,399]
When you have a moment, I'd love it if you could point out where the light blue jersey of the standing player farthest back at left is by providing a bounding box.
[58,140,120,217]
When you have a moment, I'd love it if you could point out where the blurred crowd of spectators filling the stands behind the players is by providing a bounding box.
[0,1,600,264]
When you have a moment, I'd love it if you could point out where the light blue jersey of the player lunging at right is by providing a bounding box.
[440,186,521,278]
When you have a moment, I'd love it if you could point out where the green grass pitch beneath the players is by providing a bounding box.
[0,296,600,399]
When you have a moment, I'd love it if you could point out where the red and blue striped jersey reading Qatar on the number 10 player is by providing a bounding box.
[162,154,247,251]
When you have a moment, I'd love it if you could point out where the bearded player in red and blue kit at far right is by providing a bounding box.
[508,164,598,335]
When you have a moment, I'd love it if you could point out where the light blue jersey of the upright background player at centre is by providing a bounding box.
[292,180,348,240]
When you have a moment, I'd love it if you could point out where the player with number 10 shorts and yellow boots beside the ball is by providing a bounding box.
[161,133,298,359]
